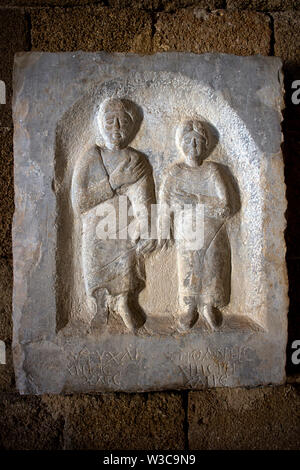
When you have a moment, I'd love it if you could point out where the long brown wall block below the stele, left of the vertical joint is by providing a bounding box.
[0,392,185,450]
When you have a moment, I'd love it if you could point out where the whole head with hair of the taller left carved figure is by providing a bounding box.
[99,98,135,150]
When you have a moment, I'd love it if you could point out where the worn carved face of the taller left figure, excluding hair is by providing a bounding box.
[102,100,133,149]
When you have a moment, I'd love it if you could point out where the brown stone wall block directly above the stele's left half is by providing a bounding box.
[31,6,152,54]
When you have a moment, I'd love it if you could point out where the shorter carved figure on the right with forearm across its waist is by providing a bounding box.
[160,120,232,329]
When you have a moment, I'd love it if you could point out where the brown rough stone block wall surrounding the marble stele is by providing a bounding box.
[0,0,300,450]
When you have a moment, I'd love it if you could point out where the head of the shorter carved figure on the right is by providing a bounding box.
[176,120,209,166]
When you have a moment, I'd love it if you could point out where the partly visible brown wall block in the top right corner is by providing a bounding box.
[273,11,300,71]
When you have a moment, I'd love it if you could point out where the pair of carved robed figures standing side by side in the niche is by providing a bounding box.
[71,105,239,332]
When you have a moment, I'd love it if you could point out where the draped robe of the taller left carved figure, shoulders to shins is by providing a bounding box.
[72,147,155,302]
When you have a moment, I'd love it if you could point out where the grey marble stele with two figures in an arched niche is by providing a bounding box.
[13,52,288,394]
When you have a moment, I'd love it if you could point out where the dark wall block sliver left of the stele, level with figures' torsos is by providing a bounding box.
[0,129,14,258]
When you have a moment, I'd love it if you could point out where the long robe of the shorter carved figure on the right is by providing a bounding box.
[161,161,231,307]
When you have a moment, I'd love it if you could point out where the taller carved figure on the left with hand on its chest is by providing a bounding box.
[72,98,155,330]
